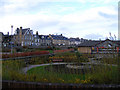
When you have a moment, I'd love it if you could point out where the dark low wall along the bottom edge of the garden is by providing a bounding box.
[2,80,120,90]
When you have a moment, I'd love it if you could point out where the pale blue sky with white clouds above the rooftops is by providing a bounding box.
[0,0,119,40]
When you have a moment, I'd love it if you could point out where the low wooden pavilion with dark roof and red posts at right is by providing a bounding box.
[78,39,120,54]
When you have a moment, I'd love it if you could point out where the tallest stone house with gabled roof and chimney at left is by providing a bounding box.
[14,27,34,46]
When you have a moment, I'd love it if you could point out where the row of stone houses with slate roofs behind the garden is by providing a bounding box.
[1,27,88,47]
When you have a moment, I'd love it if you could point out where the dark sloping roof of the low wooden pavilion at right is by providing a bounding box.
[79,39,120,47]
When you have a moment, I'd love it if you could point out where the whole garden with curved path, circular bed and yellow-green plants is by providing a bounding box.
[2,51,120,84]
